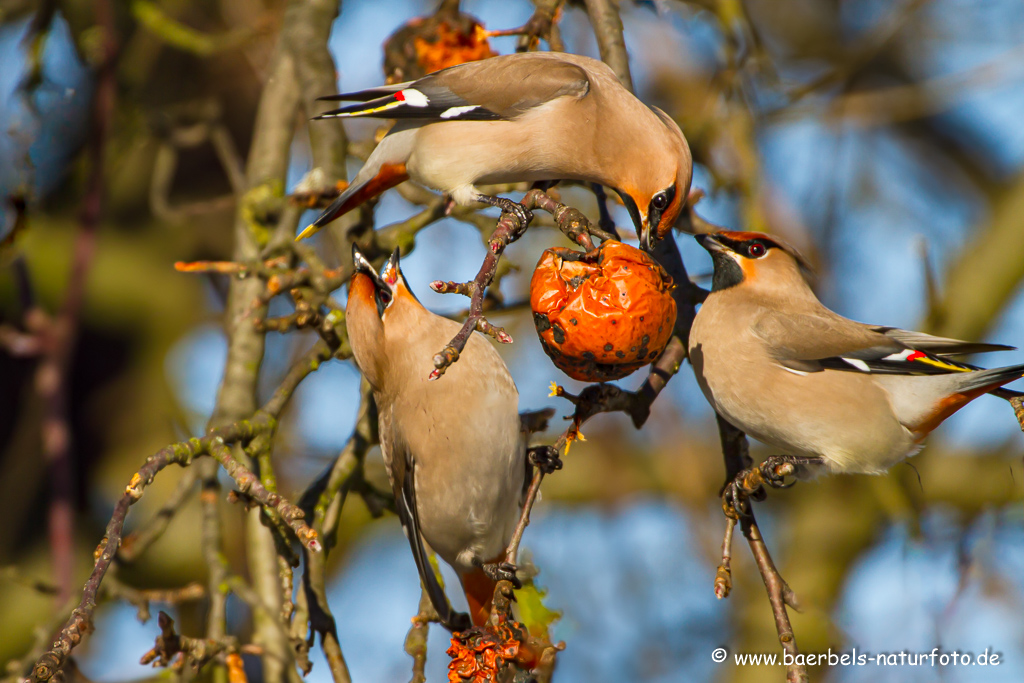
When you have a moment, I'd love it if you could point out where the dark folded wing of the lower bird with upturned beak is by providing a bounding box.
[381,428,469,631]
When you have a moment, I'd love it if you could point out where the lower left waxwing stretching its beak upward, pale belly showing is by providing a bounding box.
[346,248,527,631]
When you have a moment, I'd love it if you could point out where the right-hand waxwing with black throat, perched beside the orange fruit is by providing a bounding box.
[689,232,1024,485]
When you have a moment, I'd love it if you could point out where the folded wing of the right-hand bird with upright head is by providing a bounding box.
[753,309,1012,375]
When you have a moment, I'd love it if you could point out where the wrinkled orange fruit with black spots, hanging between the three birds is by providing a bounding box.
[529,241,676,382]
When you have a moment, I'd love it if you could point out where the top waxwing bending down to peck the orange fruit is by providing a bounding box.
[298,52,693,250]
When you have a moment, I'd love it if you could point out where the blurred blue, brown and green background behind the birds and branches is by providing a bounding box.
[0,0,1024,683]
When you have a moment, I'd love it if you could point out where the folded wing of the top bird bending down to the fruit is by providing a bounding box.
[315,54,590,121]
